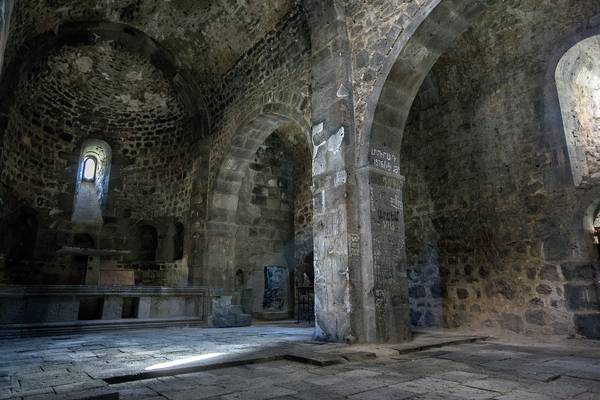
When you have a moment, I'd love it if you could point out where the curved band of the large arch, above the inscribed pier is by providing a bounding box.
[358,0,493,166]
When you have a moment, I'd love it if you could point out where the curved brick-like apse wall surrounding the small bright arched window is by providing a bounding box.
[0,37,196,284]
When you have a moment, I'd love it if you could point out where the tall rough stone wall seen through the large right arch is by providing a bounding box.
[401,0,600,335]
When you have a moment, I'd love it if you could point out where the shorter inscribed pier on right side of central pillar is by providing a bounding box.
[357,164,411,343]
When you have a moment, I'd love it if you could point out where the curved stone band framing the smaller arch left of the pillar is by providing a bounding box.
[201,103,311,292]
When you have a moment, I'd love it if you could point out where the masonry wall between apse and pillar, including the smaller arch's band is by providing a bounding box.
[203,7,311,290]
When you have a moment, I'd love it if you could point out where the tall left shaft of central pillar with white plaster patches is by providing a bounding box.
[304,0,365,342]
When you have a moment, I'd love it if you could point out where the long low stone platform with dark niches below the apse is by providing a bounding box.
[0,286,210,330]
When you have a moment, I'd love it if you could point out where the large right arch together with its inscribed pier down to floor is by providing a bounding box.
[346,0,495,342]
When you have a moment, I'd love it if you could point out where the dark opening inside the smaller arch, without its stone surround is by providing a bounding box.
[235,130,312,319]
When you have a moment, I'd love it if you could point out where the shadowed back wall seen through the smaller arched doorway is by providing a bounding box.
[235,132,294,313]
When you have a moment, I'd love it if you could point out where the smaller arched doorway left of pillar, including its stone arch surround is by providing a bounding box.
[203,105,312,319]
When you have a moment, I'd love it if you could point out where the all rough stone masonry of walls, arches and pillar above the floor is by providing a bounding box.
[0,0,600,343]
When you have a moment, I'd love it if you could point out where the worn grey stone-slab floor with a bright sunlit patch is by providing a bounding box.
[0,325,600,400]
